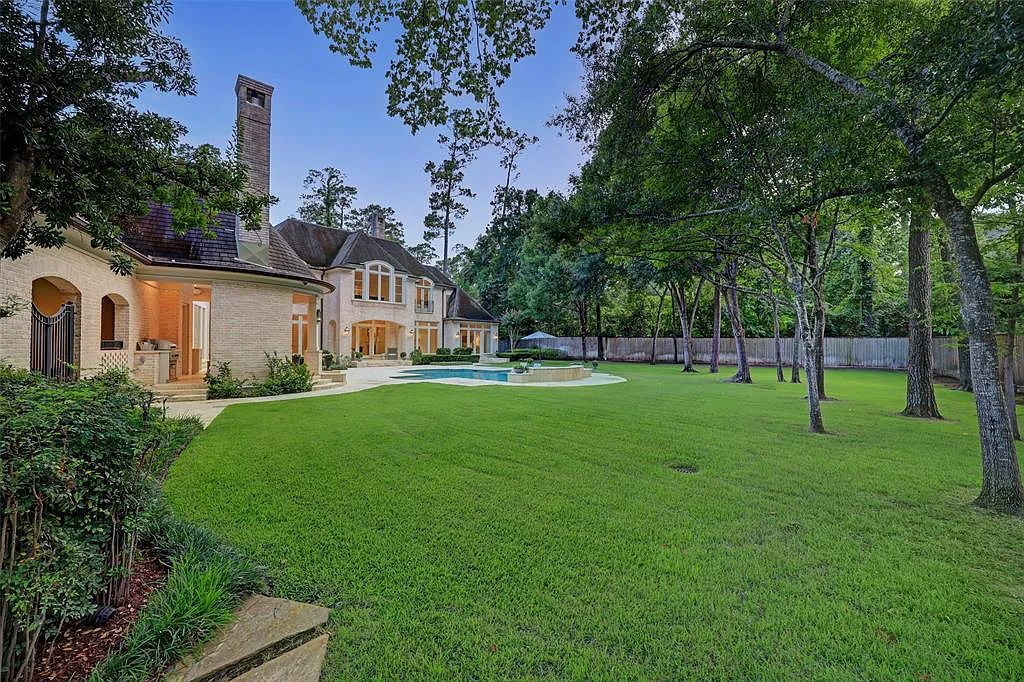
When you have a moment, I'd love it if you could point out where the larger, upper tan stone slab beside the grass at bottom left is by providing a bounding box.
[166,595,331,682]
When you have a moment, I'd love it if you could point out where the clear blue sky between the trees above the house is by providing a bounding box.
[141,0,583,248]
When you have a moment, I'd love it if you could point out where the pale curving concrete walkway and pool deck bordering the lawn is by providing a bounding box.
[167,365,626,424]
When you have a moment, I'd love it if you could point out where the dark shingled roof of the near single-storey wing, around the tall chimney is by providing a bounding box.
[121,204,330,287]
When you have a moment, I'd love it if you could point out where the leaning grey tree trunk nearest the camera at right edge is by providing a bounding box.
[926,173,1024,513]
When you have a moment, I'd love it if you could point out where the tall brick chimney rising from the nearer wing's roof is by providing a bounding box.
[234,74,273,265]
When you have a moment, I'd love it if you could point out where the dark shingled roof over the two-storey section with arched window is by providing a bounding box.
[274,218,455,288]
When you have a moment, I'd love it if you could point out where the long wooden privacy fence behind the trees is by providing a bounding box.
[518,336,1024,383]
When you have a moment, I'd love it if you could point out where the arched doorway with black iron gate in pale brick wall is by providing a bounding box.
[30,276,82,381]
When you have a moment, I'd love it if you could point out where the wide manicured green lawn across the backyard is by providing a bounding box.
[167,364,1024,680]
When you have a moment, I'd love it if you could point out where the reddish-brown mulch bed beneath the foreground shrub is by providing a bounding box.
[34,553,167,682]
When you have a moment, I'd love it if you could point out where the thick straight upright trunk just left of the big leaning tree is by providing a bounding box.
[903,201,942,419]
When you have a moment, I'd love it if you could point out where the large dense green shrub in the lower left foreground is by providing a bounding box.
[0,367,178,681]
